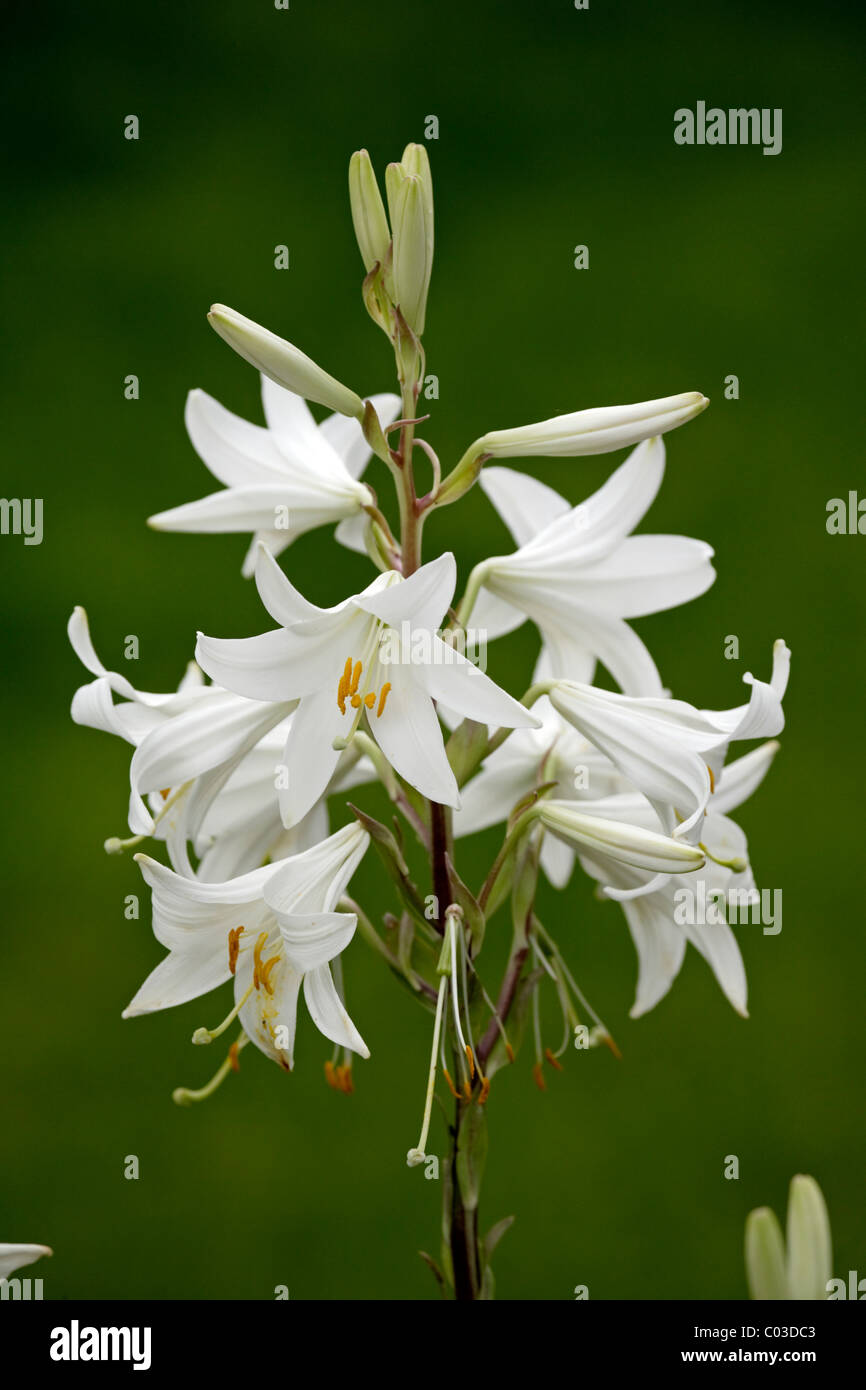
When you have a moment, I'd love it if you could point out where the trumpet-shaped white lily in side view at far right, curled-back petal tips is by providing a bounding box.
[549,639,791,837]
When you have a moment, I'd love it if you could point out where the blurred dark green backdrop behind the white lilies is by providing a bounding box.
[0,0,866,1300]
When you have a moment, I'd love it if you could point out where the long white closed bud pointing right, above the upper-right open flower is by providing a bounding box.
[477,391,709,459]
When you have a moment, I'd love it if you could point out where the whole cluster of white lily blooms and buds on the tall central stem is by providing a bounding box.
[70,146,790,1163]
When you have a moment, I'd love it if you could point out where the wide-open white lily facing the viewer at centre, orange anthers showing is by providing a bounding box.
[196,550,538,827]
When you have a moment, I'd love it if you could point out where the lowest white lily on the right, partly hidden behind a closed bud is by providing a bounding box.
[567,742,778,1019]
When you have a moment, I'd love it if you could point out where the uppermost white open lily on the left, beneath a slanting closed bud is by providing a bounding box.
[147,375,400,577]
